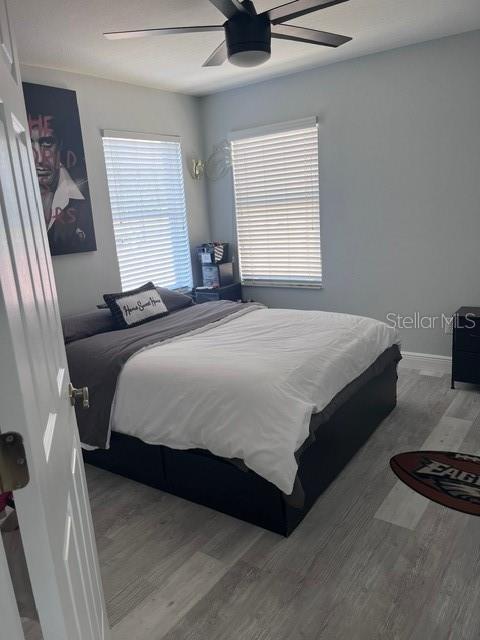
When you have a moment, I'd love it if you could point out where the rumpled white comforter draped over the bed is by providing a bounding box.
[111,308,398,494]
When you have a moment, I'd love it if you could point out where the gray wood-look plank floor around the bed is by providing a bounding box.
[87,370,480,640]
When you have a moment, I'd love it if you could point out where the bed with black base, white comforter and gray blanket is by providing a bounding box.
[66,301,401,536]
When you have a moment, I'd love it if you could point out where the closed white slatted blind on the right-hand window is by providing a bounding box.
[231,118,322,286]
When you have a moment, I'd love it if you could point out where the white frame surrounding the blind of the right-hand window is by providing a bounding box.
[228,116,325,289]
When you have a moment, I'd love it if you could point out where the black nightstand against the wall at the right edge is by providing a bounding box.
[452,307,480,389]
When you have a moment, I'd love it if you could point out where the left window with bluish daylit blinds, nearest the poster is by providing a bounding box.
[103,131,192,290]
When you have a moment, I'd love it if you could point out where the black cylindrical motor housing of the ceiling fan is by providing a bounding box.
[224,14,272,67]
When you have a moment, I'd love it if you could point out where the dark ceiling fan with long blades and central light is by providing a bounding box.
[104,0,352,67]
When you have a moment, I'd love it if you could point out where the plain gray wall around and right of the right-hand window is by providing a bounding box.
[201,31,480,354]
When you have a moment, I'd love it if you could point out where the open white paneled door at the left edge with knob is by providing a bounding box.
[0,0,109,640]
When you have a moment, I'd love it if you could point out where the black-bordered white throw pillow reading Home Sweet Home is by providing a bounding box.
[103,282,168,329]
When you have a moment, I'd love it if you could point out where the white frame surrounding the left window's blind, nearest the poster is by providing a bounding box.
[101,129,194,292]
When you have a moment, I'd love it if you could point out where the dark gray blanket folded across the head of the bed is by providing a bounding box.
[66,300,258,449]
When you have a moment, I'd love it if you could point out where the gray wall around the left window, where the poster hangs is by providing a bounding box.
[22,67,210,313]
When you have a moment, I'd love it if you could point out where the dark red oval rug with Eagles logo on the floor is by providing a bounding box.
[390,451,480,516]
